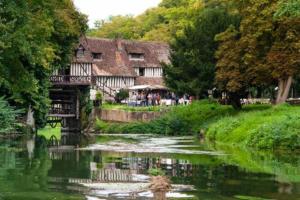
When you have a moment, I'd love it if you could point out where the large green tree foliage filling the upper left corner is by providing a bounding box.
[0,0,86,126]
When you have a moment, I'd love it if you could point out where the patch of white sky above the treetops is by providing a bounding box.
[73,0,161,27]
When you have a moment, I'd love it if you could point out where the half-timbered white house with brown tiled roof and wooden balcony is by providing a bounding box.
[52,37,169,97]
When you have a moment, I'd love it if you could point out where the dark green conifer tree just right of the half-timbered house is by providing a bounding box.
[164,8,239,98]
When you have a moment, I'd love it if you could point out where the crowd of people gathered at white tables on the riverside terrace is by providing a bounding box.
[128,91,193,106]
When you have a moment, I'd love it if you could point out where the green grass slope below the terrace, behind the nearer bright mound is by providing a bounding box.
[95,100,270,135]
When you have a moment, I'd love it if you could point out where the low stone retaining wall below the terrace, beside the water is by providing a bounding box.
[96,109,163,123]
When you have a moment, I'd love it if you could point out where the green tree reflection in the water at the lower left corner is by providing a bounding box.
[0,138,81,200]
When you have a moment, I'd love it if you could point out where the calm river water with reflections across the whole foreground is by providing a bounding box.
[0,135,300,200]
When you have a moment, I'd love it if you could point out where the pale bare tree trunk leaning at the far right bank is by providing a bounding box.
[276,76,293,104]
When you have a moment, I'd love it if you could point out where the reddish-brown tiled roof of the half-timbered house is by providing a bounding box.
[76,37,169,76]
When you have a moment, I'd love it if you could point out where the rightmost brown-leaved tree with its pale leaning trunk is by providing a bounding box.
[268,0,300,104]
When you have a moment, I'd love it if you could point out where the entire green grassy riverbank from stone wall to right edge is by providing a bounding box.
[95,101,300,150]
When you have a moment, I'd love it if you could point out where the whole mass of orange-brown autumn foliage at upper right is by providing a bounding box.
[216,0,300,108]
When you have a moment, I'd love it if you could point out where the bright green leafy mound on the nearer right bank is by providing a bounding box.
[207,105,300,149]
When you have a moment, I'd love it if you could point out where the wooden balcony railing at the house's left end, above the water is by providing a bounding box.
[50,75,92,85]
